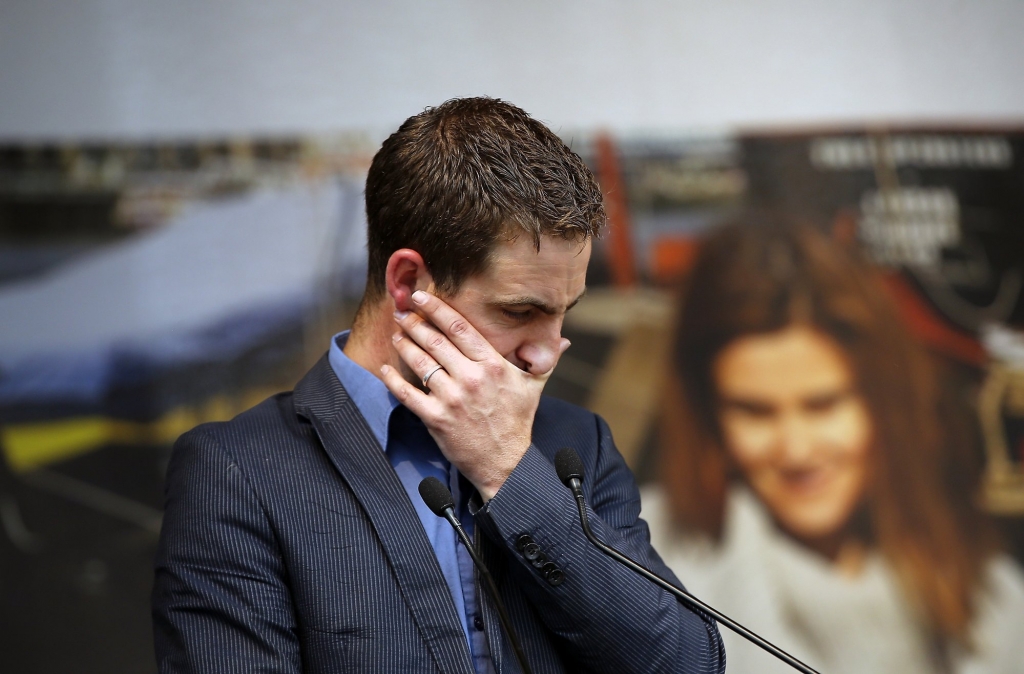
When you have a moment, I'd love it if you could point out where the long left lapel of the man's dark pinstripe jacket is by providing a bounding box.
[295,356,473,674]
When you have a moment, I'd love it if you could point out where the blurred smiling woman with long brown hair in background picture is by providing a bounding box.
[643,218,1024,674]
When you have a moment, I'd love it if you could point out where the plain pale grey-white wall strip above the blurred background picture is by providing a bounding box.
[0,0,1024,139]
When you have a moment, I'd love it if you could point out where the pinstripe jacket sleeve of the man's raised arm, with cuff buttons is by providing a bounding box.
[477,409,725,674]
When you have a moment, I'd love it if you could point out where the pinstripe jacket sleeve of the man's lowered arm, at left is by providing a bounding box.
[153,427,301,674]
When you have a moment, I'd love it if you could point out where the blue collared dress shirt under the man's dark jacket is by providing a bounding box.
[328,330,494,674]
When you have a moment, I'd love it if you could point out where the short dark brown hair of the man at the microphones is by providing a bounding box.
[366,98,605,299]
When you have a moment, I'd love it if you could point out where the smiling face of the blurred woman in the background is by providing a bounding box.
[712,325,873,545]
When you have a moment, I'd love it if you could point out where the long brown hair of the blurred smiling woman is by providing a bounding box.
[660,215,994,647]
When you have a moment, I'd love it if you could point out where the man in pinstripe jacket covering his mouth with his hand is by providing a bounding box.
[154,98,725,674]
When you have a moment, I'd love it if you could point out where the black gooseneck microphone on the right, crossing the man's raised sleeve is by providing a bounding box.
[557,447,820,674]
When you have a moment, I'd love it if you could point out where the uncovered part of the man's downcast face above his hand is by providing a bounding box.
[434,236,591,375]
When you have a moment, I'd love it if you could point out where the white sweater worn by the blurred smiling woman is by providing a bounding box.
[641,487,1024,674]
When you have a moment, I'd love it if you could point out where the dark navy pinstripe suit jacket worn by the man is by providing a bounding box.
[153,357,725,674]
